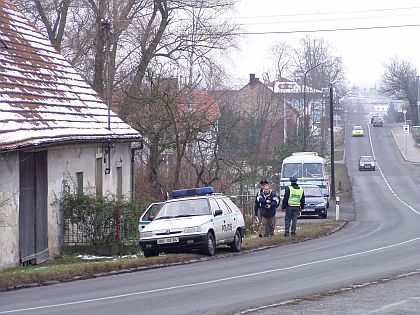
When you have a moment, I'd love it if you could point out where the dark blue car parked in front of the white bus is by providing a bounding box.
[299,185,328,219]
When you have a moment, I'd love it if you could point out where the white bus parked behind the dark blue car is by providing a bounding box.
[280,152,330,208]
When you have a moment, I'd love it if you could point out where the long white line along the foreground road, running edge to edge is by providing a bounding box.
[0,236,420,314]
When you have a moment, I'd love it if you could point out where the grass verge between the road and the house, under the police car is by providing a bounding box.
[0,221,346,291]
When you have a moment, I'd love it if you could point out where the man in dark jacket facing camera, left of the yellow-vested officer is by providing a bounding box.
[257,184,279,237]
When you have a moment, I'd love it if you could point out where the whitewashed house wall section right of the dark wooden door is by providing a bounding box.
[48,143,131,256]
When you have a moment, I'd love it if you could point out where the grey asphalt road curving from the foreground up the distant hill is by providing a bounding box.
[0,127,420,315]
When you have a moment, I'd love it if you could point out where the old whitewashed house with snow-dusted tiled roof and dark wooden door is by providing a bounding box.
[0,0,141,269]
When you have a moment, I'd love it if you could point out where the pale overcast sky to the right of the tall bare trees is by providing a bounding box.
[226,0,420,86]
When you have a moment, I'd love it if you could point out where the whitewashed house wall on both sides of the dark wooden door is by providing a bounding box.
[0,143,131,270]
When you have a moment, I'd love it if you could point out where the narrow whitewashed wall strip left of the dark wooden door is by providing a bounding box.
[0,152,19,270]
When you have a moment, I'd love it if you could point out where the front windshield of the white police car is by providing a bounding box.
[155,198,211,220]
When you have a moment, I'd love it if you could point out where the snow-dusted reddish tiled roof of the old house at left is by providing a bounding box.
[0,0,141,151]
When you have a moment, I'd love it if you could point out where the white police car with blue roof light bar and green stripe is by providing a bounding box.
[139,187,245,257]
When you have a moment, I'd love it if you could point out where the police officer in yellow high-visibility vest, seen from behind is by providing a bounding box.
[282,176,305,237]
